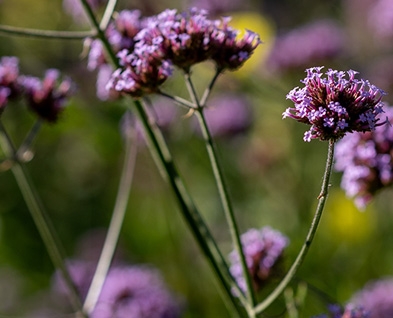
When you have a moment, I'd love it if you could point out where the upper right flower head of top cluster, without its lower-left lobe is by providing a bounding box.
[135,8,260,70]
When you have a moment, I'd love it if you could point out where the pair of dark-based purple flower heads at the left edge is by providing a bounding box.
[0,56,74,122]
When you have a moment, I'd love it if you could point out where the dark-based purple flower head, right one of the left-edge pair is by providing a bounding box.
[21,69,74,122]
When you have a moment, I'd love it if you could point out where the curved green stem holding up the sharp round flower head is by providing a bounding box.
[255,140,334,313]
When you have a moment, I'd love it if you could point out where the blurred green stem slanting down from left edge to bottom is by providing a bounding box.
[0,121,87,317]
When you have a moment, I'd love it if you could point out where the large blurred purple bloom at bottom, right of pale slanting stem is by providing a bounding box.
[91,266,182,318]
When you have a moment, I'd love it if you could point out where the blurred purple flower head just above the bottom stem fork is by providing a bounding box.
[229,226,289,291]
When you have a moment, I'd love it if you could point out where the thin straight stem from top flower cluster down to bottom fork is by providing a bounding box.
[185,72,256,317]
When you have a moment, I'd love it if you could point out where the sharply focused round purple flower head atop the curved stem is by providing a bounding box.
[283,67,385,141]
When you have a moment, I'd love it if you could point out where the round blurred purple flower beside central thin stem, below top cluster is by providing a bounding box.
[193,94,252,137]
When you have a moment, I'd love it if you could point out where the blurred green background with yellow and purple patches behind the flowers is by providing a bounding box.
[0,0,393,318]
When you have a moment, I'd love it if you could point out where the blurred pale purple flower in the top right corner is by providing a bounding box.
[368,0,393,40]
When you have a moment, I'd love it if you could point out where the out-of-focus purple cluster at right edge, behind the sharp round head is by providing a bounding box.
[335,107,393,209]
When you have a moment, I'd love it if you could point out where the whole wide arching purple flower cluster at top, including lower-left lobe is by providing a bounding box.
[102,8,260,98]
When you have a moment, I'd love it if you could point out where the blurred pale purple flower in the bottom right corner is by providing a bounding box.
[351,278,393,318]
